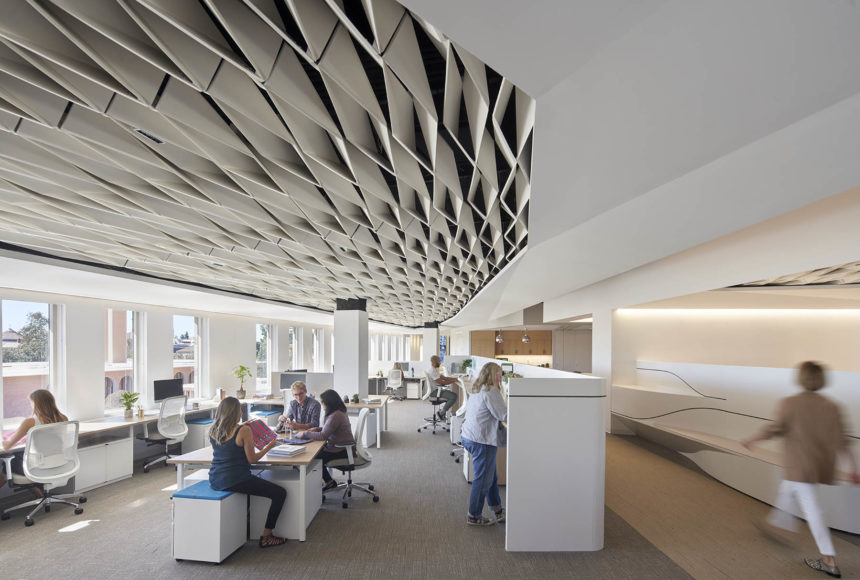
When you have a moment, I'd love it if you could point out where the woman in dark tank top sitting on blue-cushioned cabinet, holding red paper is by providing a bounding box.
[209,397,287,548]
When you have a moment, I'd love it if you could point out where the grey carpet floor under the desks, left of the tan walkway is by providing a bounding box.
[0,401,690,579]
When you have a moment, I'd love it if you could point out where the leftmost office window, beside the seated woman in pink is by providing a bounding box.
[0,300,52,424]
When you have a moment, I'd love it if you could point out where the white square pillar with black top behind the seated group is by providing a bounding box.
[334,298,368,399]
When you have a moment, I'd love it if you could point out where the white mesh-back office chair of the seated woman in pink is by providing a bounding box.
[0,421,87,526]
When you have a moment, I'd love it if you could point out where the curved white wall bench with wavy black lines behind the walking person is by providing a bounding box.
[611,361,860,534]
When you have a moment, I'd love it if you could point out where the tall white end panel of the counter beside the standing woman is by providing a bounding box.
[505,376,606,552]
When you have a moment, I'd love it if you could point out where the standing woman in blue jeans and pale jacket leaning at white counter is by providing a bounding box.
[460,363,508,526]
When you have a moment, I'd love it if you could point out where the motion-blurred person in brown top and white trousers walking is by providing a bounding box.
[741,361,860,578]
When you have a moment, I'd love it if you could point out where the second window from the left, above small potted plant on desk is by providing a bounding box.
[105,308,137,409]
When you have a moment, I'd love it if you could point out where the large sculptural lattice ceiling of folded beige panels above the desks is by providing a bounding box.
[0,0,534,326]
